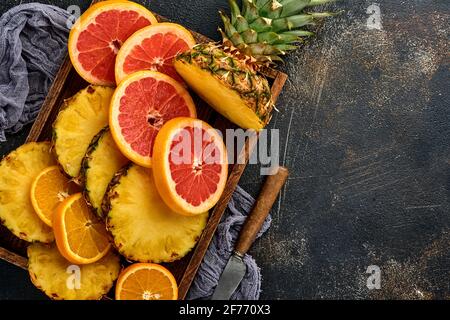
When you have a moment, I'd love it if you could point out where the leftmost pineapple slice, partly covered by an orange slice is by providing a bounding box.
[0,142,56,243]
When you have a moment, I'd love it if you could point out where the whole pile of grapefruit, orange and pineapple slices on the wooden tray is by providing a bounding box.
[0,0,232,300]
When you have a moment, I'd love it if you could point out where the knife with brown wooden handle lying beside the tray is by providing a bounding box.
[212,167,289,300]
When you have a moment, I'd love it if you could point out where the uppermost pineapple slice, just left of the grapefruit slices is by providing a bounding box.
[53,86,114,182]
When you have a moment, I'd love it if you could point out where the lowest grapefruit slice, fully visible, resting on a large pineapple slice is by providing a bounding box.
[153,118,228,215]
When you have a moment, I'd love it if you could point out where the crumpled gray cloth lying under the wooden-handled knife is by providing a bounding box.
[187,187,272,300]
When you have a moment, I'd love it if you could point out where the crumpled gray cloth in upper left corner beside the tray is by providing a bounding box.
[0,3,70,142]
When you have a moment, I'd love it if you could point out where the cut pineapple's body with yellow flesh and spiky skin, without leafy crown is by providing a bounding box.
[174,43,273,131]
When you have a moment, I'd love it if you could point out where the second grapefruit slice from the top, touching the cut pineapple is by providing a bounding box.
[116,22,195,83]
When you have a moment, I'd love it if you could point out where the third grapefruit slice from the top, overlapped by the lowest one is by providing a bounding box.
[109,71,197,168]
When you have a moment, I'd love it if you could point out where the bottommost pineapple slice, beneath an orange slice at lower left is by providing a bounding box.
[28,243,121,300]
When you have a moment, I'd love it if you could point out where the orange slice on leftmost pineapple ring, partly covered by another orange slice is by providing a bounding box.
[30,166,70,227]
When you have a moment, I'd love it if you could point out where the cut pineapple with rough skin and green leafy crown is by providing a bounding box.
[175,0,333,130]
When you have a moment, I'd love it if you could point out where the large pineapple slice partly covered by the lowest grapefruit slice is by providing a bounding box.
[103,164,208,263]
